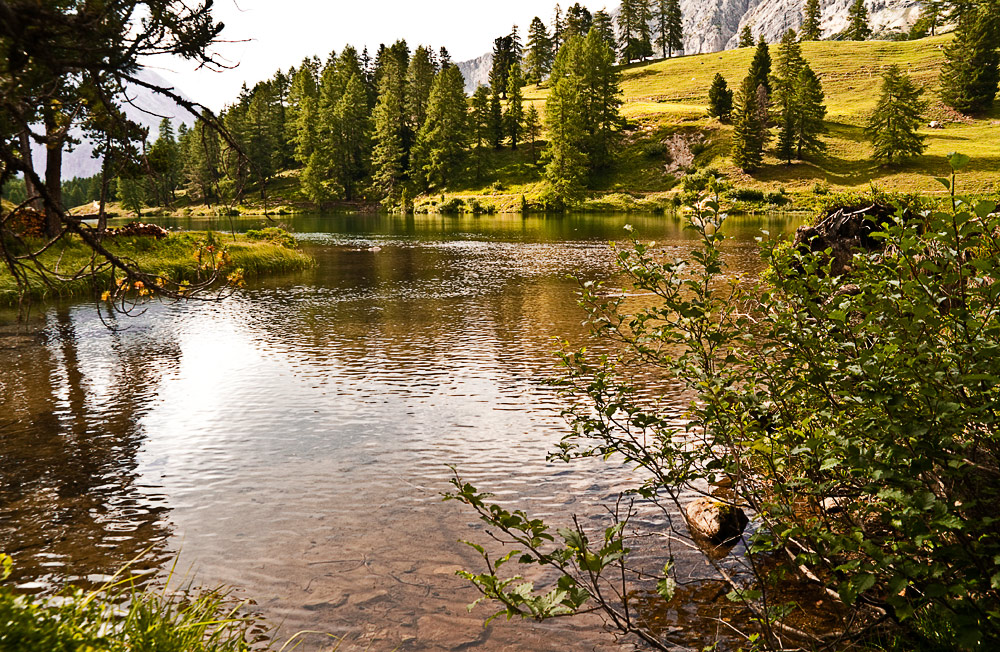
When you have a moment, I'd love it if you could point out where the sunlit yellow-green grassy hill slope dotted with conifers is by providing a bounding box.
[526,35,1000,193]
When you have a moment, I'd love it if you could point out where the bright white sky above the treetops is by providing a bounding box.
[154,0,617,110]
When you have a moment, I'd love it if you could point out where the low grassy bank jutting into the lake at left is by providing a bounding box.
[0,230,313,306]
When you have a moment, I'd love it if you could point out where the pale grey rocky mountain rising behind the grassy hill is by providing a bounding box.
[458,0,921,93]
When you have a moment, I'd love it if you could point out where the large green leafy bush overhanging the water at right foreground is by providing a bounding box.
[450,155,1000,650]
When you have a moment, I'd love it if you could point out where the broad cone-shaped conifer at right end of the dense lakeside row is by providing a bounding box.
[411,66,467,190]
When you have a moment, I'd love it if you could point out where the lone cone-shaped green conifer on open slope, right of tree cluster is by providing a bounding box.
[865,65,927,163]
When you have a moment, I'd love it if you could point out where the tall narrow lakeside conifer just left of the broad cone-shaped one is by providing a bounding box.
[372,58,406,204]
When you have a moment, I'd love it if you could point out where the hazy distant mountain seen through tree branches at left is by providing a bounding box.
[32,69,194,179]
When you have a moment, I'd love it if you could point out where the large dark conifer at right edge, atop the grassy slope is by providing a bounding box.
[940,4,1000,114]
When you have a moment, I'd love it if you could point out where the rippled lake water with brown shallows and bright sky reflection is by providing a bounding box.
[0,216,795,651]
